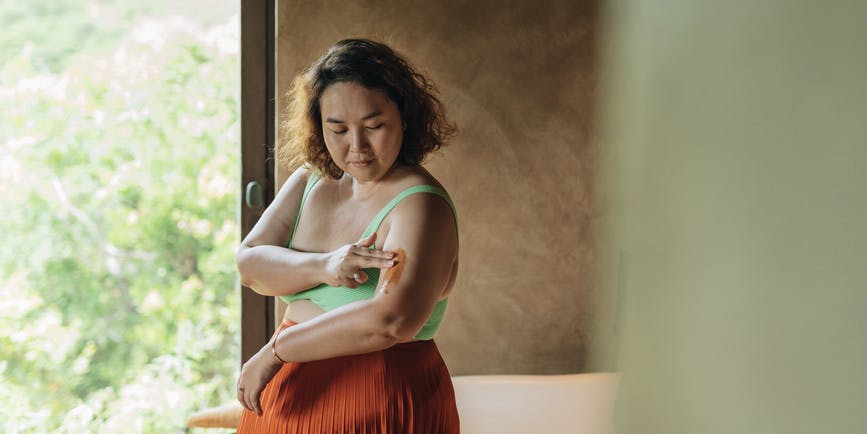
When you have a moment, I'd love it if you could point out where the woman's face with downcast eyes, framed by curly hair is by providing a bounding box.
[319,82,403,182]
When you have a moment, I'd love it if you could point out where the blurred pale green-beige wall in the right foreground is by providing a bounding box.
[597,0,867,434]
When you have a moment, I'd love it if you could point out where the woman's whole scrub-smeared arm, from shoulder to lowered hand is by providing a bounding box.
[239,194,458,412]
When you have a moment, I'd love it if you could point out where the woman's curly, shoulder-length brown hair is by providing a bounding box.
[277,39,456,179]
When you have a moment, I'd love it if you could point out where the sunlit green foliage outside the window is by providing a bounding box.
[0,1,240,433]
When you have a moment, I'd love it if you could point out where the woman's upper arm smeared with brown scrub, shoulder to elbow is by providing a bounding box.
[374,194,458,339]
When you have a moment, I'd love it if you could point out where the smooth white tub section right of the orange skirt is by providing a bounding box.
[452,373,620,434]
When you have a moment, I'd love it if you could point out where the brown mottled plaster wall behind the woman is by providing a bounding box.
[278,0,596,374]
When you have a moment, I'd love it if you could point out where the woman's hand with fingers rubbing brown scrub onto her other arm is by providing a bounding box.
[322,232,394,288]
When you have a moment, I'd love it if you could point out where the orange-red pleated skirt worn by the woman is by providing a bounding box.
[238,322,460,434]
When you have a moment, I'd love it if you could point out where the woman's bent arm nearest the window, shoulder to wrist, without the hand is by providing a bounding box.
[236,168,328,296]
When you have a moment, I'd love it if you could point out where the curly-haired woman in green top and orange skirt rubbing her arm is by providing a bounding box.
[231,39,459,433]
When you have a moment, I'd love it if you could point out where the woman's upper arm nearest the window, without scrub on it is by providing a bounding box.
[241,167,310,249]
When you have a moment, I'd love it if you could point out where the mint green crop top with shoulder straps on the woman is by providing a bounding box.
[280,172,457,340]
